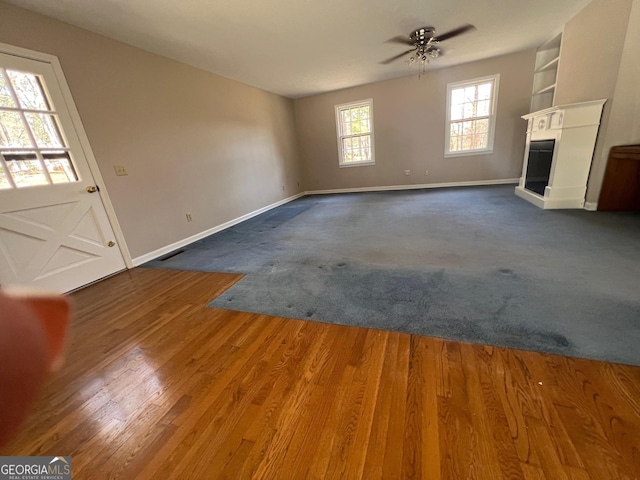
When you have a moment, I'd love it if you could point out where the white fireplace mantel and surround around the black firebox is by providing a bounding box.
[515,99,606,209]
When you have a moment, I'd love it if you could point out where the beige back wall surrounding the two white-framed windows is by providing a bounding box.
[294,50,535,190]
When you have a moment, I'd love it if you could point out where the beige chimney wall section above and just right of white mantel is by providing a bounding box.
[555,0,640,202]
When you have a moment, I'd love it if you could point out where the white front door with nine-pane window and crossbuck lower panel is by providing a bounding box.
[0,53,126,292]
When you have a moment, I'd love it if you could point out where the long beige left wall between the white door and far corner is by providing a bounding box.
[0,2,300,258]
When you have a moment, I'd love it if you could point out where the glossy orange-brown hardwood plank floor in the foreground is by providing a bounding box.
[2,269,640,480]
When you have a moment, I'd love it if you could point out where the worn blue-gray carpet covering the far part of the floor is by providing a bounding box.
[145,186,640,365]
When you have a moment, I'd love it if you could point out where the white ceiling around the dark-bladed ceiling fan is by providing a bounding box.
[9,0,590,98]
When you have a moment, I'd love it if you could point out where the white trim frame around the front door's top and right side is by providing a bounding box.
[0,42,134,268]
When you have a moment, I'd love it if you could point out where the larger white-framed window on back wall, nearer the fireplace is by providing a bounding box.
[444,75,500,156]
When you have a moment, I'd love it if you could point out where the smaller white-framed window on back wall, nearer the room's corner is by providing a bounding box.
[336,99,375,167]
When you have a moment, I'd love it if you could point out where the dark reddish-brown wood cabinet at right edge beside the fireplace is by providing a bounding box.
[598,145,640,211]
